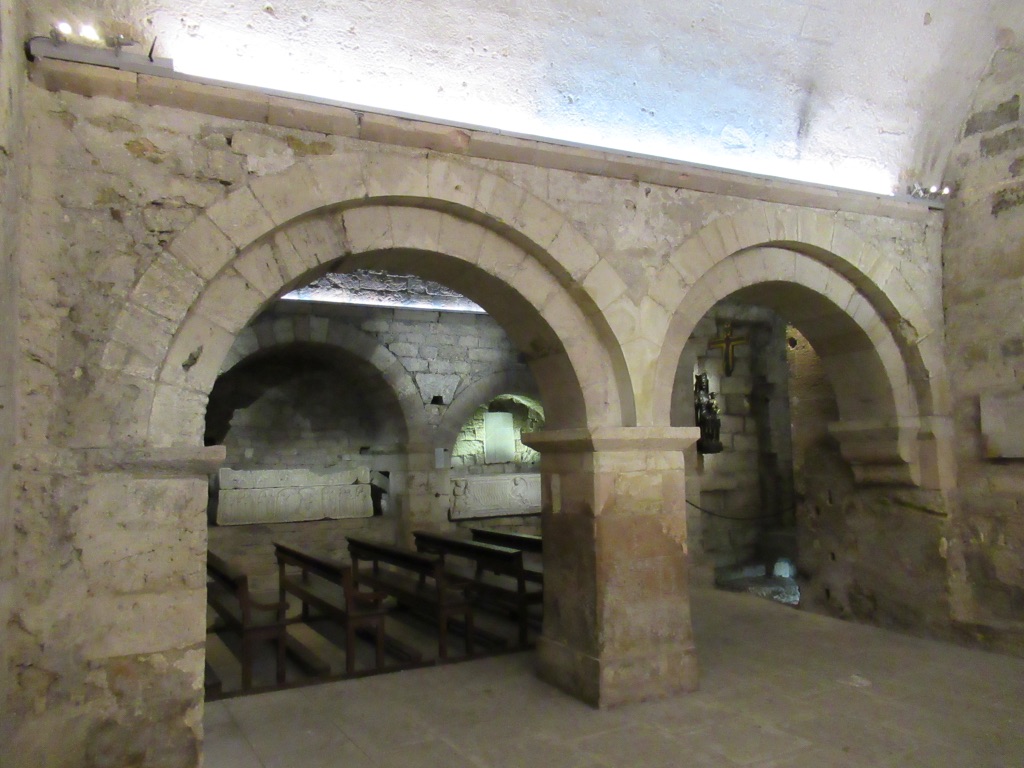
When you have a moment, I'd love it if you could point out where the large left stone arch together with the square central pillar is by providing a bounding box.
[103,158,695,749]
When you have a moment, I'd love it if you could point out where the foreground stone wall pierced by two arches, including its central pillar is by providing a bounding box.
[7,57,944,767]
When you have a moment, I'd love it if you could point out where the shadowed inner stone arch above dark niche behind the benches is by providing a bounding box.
[218,315,431,442]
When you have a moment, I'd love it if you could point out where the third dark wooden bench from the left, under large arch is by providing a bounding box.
[347,537,473,659]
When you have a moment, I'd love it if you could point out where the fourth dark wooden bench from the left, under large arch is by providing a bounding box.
[413,530,544,646]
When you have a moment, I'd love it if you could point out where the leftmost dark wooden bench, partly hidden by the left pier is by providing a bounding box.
[206,551,288,690]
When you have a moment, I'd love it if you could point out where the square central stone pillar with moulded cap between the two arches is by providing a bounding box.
[522,427,699,708]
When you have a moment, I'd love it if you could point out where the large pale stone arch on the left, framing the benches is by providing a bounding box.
[102,153,636,446]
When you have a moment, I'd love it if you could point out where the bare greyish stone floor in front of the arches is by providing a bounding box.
[205,591,1024,768]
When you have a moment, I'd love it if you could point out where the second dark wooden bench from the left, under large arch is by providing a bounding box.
[273,542,386,675]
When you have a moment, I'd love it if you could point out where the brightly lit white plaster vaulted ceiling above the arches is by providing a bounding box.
[26,0,1024,193]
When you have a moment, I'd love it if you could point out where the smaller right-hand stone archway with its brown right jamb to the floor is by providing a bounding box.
[658,243,951,627]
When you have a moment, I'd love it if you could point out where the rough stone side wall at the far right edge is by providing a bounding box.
[943,44,1024,653]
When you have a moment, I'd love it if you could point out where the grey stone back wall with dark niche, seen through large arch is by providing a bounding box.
[207,301,536,589]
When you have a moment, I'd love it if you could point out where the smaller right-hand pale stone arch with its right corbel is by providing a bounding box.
[653,247,940,485]
